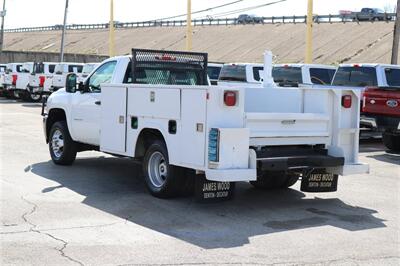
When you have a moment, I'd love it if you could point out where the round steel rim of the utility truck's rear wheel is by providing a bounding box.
[147,152,168,188]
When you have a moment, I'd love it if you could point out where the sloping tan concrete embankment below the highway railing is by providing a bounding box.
[4,22,400,64]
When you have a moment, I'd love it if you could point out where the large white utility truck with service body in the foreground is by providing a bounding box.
[43,49,369,198]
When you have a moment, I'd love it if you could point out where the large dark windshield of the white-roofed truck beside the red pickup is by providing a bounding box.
[332,67,378,87]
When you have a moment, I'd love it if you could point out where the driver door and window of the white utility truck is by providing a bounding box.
[71,61,117,146]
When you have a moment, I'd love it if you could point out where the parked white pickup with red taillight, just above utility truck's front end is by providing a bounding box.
[29,62,58,95]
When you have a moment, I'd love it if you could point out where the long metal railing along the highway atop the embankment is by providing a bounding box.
[5,13,396,33]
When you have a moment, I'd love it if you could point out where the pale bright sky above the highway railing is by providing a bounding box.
[0,0,397,29]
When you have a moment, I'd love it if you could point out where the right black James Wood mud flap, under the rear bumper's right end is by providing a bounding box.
[300,169,339,192]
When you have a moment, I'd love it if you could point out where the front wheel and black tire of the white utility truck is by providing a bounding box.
[49,121,78,165]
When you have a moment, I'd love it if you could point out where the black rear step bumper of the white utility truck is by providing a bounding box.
[257,148,345,171]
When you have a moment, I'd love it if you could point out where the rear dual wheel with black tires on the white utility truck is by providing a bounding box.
[143,139,186,198]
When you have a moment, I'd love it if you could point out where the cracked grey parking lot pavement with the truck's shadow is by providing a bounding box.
[0,98,400,265]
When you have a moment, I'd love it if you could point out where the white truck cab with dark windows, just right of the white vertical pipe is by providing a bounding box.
[272,64,337,87]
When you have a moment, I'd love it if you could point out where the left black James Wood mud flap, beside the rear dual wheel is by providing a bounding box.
[195,175,235,203]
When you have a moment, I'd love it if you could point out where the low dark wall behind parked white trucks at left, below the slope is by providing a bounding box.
[0,51,108,63]
